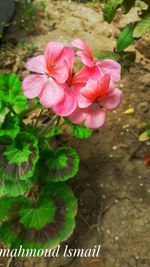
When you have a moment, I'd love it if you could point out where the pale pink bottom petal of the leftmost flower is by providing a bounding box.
[39,78,64,108]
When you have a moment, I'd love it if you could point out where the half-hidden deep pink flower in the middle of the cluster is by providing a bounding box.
[53,47,87,116]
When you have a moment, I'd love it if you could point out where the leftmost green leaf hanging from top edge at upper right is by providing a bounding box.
[103,0,123,23]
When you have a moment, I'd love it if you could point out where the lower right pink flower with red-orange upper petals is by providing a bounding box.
[69,74,122,129]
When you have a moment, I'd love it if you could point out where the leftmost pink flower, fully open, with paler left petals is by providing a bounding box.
[23,42,68,108]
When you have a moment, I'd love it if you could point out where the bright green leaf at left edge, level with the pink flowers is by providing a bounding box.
[0,73,27,111]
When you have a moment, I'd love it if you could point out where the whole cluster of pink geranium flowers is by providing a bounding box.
[23,39,122,129]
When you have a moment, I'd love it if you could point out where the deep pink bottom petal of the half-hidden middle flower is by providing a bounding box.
[53,87,77,116]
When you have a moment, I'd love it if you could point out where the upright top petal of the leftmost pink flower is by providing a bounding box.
[44,41,63,70]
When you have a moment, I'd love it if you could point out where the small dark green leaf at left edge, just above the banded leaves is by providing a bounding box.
[0,112,20,138]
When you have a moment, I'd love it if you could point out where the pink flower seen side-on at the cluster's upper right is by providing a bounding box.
[72,39,121,82]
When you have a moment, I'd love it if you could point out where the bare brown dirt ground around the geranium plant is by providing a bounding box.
[0,0,150,267]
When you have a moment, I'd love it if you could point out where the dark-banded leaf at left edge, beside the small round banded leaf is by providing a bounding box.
[0,132,39,180]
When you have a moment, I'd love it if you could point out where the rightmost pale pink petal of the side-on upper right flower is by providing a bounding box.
[98,59,121,82]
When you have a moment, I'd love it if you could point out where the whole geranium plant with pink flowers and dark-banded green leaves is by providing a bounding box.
[0,39,122,251]
